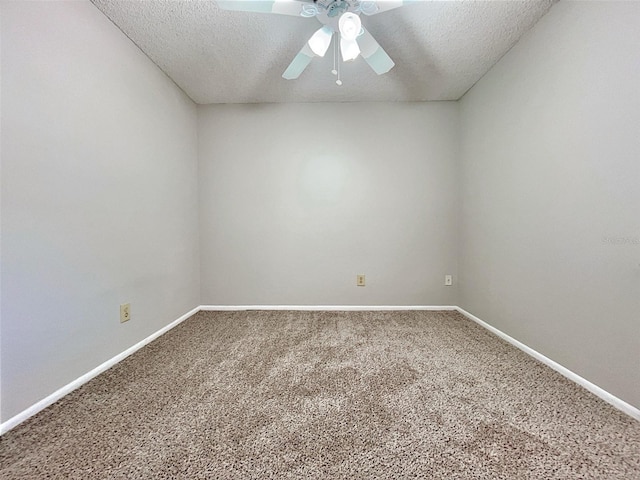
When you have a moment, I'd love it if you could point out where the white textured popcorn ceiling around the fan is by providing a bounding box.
[91,0,555,104]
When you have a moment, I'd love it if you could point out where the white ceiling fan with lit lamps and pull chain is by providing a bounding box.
[218,0,415,85]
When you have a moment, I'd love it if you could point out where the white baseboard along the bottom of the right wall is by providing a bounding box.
[456,307,640,421]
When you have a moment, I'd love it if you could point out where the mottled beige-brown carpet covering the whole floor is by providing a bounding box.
[0,311,640,480]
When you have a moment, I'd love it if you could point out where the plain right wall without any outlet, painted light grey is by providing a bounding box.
[460,2,640,407]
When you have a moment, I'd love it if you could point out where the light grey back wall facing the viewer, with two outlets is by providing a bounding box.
[198,102,458,305]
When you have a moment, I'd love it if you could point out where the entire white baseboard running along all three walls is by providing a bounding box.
[0,305,640,435]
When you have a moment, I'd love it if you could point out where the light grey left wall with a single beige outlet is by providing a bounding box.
[0,1,199,421]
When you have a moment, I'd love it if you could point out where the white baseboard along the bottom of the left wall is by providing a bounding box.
[0,307,200,435]
